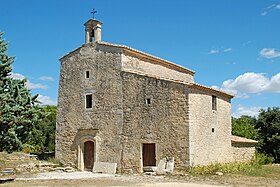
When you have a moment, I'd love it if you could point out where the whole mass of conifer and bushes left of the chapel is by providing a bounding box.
[0,33,56,153]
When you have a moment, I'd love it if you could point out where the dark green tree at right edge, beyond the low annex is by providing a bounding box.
[256,107,280,163]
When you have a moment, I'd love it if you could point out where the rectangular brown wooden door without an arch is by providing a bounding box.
[142,143,156,166]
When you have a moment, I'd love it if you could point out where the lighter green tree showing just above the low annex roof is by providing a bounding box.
[232,116,259,140]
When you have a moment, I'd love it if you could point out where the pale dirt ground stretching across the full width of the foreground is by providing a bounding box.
[2,172,280,187]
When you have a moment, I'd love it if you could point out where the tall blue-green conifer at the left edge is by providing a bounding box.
[0,33,43,152]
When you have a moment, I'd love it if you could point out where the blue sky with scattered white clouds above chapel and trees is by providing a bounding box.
[0,0,280,116]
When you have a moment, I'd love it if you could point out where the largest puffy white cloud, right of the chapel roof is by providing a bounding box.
[216,72,280,98]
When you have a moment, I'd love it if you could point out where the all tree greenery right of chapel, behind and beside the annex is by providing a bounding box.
[232,107,280,163]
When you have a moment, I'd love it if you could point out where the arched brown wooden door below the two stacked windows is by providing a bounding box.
[84,141,94,171]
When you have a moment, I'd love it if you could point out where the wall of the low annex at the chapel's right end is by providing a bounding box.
[231,143,256,162]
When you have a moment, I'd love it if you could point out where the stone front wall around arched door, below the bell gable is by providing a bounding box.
[56,44,123,165]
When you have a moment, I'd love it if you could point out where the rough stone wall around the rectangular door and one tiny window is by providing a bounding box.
[122,72,189,172]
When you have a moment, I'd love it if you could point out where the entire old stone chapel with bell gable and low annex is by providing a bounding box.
[55,18,256,173]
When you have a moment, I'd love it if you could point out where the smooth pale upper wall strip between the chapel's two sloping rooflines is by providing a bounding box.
[121,54,194,82]
